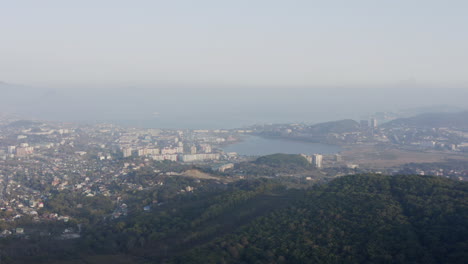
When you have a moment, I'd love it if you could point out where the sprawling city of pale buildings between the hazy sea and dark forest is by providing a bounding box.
[0,111,468,239]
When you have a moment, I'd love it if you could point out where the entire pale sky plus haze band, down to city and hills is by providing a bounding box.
[0,0,468,128]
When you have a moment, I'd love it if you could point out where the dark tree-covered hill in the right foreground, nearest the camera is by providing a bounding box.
[173,176,468,263]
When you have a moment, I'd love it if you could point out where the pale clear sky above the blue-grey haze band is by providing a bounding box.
[0,0,468,86]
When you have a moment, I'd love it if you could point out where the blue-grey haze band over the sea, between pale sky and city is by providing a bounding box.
[0,81,468,128]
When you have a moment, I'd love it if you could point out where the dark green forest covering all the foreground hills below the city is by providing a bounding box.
[3,175,468,263]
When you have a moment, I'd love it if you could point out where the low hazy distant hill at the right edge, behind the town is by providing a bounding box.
[383,111,468,129]
